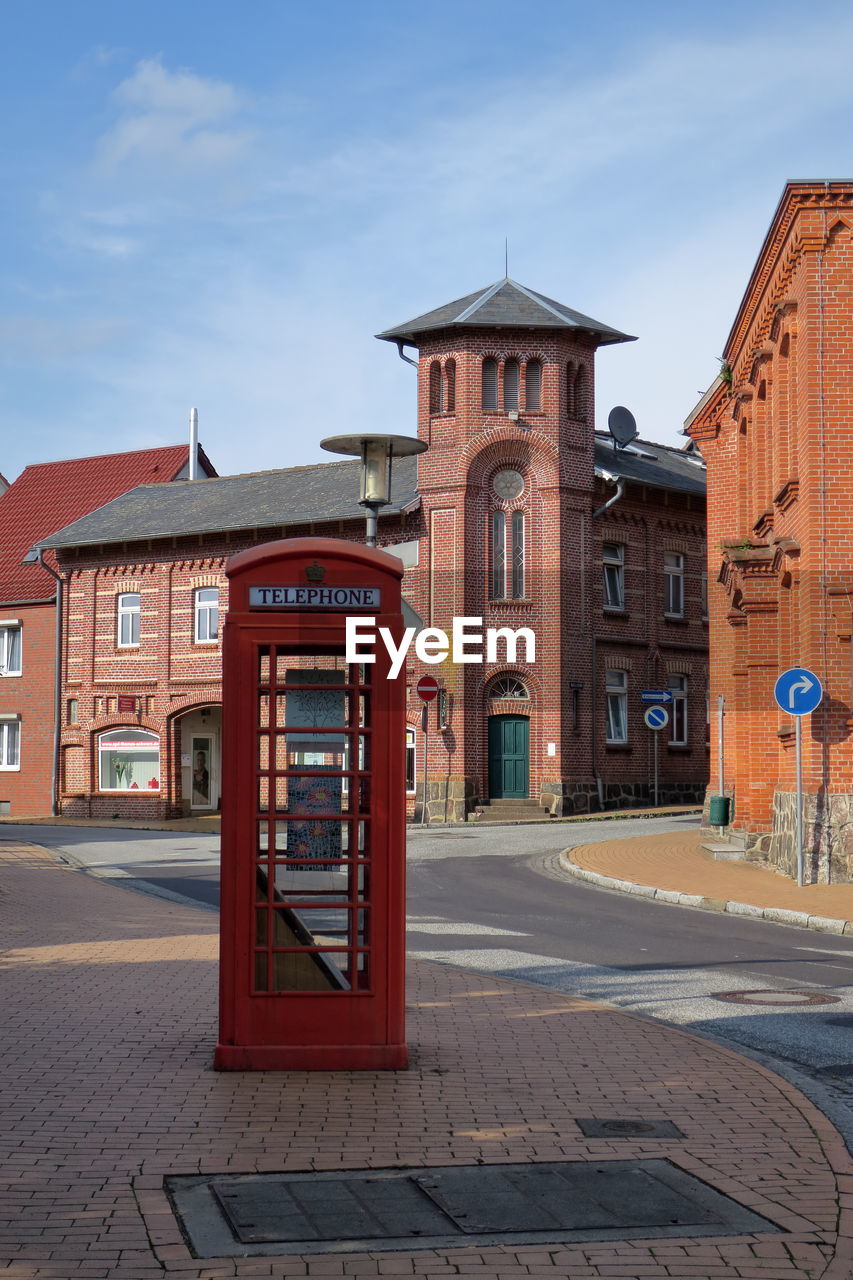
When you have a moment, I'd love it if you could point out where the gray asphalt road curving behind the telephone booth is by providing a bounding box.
[6,817,853,1149]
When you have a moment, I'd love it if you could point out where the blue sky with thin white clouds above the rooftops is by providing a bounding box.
[0,0,853,480]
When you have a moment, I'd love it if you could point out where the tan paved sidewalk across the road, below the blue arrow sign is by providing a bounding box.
[564,831,853,933]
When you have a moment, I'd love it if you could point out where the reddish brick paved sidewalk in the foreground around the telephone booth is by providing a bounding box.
[0,841,853,1280]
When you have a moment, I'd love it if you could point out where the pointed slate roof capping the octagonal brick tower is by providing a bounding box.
[377,275,637,347]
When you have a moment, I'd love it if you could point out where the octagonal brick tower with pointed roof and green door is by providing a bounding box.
[378,278,631,820]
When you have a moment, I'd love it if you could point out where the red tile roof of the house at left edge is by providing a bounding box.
[0,444,201,604]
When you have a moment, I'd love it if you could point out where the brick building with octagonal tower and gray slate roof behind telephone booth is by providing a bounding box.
[36,279,707,820]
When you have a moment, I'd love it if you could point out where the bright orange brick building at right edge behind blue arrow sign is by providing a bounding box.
[685,182,853,882]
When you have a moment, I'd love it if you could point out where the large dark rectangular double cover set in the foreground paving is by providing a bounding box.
[165,1160,779,1258]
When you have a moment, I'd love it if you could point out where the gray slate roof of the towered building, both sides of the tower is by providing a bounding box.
[37,433,706,548]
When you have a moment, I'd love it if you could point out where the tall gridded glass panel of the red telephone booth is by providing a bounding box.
[254,645,373,995]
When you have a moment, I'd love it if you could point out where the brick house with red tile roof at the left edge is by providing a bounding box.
[0,444,214,817]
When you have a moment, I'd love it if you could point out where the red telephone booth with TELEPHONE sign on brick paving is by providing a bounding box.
[214,538,407,1071]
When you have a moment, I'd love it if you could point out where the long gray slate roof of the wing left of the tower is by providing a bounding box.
[38,457,420,547]
